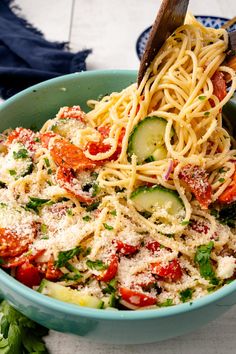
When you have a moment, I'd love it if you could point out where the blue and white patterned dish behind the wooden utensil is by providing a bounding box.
[136,15,236,59]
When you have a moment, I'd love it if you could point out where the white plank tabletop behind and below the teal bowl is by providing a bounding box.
[13,0,236,354]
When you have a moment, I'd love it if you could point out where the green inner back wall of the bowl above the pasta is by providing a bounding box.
[0,70,137,131]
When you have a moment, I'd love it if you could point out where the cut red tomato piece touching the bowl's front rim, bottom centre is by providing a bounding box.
[119,287,157,307]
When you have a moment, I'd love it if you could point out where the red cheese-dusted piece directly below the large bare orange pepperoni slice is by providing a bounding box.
[56,167,94,203]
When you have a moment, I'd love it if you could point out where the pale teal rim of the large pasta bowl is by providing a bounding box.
[0,70,236,320]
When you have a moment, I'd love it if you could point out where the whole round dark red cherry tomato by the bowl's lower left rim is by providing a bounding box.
[16,262,42,288]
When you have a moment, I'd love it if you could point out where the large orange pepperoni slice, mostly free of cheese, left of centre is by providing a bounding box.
[50,139,96,171]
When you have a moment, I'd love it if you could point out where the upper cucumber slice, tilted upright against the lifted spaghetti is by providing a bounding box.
[128,116,174,164]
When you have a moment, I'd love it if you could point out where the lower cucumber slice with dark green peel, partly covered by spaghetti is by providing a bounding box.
[130,185,184,216]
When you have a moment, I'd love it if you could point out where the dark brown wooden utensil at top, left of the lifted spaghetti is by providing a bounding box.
[138,0,189,85]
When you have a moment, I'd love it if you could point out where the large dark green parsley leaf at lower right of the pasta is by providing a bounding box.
[194,241,219,285]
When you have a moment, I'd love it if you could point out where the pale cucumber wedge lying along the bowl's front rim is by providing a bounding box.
[38,279,104,309]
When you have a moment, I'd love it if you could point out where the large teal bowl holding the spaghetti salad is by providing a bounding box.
[0,70,236,344]
